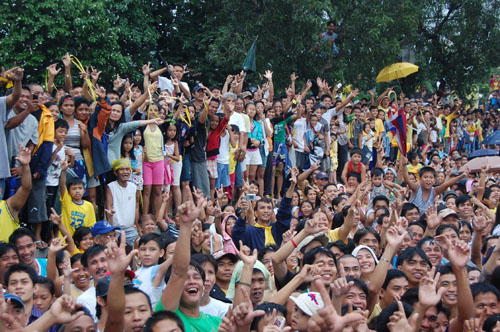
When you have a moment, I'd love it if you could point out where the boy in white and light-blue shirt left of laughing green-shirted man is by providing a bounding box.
[134,233,165,307]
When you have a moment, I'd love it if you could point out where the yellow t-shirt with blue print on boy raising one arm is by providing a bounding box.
[61,189,96,236]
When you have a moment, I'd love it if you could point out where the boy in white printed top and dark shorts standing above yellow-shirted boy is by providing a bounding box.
[46,119,75,211]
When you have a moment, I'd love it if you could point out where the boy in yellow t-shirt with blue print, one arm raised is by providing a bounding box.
[59,160,96,236]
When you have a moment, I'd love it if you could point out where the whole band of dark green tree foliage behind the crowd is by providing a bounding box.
[0,0,500,94]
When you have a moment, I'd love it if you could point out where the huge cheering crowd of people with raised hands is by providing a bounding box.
[0,56,500,332]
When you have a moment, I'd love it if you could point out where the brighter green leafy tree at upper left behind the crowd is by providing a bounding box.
[0,0,158,83]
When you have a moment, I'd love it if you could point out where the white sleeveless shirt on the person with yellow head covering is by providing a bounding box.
[108,181,137,228]
